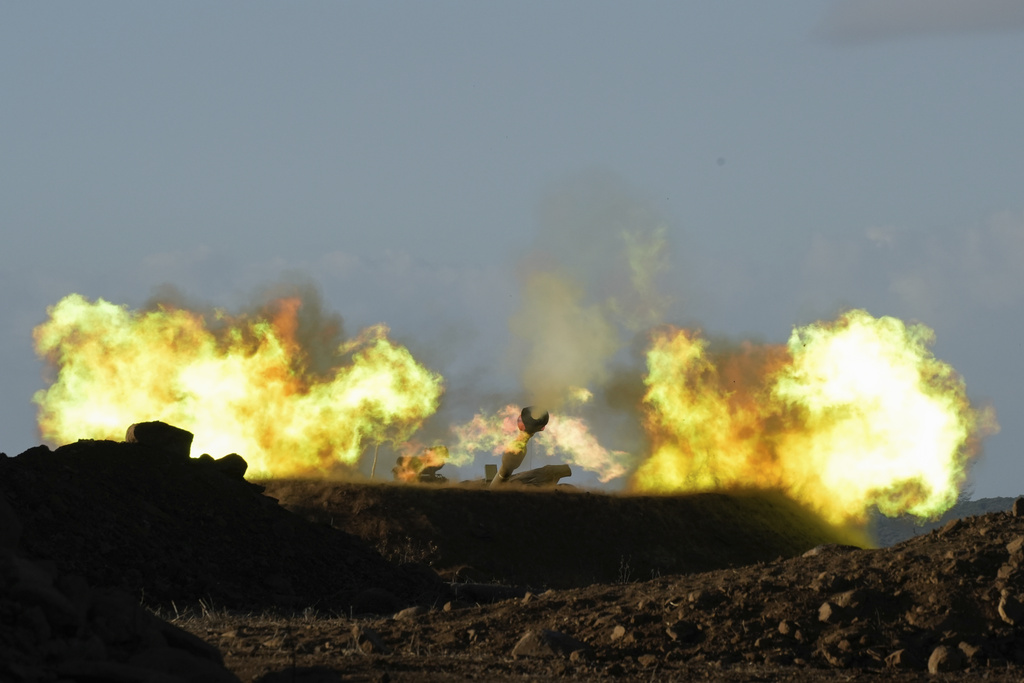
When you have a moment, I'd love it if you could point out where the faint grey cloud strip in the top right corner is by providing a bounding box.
[818,0,1024,44]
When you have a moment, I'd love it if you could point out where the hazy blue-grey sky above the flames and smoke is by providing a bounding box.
[0,0,1024,497]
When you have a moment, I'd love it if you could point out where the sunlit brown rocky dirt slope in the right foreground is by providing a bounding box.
[189,500,1024,681]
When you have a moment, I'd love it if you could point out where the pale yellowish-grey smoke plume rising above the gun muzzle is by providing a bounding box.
[509,176,669,410]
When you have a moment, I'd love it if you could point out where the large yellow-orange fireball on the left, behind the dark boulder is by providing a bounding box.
[34,294,442,476]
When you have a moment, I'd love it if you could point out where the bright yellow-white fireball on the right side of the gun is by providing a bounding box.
[632,310,998,523]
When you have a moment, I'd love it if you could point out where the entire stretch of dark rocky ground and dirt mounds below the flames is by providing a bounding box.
[0,430,1024,683]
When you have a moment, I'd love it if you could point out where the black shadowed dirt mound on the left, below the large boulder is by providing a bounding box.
[0,440,446,613]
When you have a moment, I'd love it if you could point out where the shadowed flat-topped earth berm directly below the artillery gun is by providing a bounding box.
[262,480,865,591]
